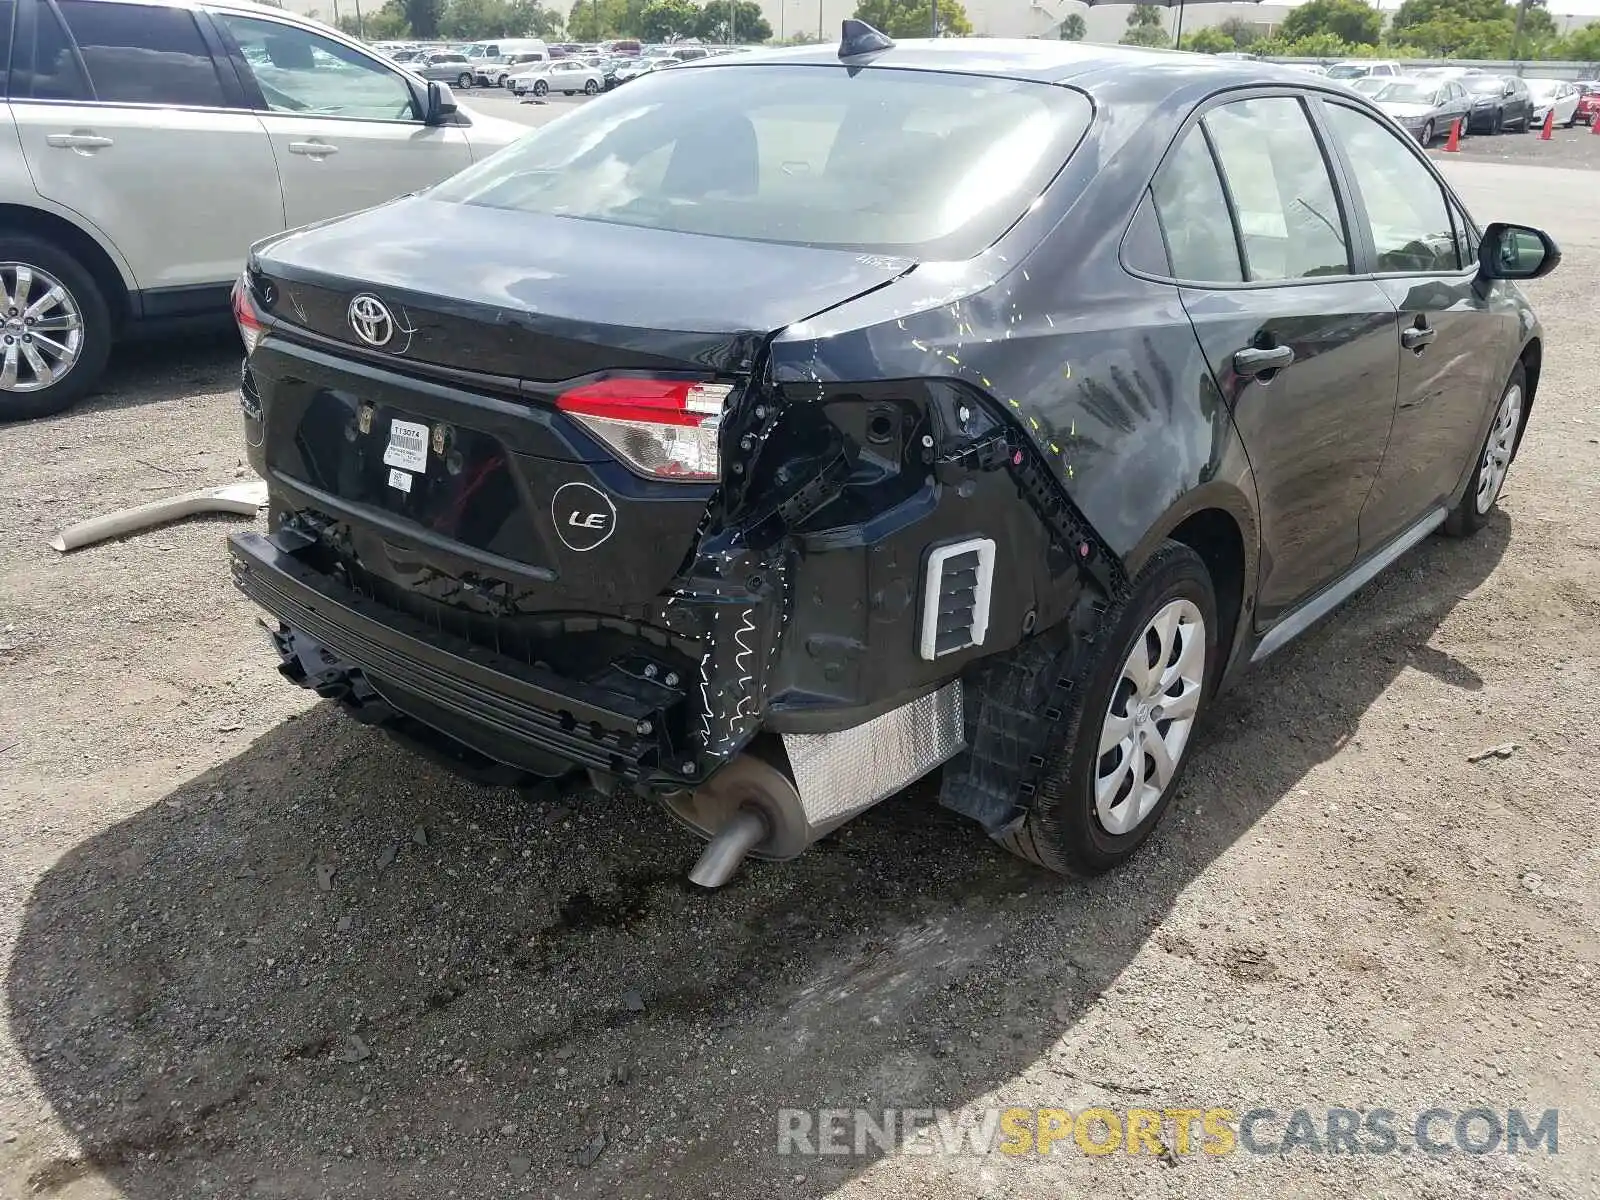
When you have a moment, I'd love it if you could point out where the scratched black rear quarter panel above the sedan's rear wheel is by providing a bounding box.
[768,77,1258,653]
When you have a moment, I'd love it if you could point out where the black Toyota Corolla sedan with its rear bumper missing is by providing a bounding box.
[232,22,1558,885]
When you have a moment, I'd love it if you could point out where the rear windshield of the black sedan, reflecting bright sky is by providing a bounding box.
[430,64,1091,259]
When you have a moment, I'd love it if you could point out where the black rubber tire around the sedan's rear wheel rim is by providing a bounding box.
[997,542,1219,875]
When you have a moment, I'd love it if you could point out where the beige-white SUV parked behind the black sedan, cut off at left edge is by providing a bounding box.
[0,0,528,421]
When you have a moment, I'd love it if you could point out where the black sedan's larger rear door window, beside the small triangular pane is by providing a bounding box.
[1203,96,1350,282]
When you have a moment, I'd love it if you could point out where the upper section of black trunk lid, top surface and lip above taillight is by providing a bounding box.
[253,197,914,382]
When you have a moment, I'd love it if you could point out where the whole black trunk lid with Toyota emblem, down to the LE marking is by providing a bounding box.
[238,198,914,614]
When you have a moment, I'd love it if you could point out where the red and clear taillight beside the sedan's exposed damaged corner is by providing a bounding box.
[555,378,733,483]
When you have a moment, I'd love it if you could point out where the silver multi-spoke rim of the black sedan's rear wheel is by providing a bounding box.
[1093,598,1206,835]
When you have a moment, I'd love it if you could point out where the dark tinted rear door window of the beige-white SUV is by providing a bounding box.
[55,0,227,109]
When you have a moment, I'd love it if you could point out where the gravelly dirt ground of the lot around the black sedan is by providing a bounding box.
[0,160,1600,1200]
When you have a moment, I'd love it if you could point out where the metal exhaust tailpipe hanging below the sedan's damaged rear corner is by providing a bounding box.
[666,754,814,888]
